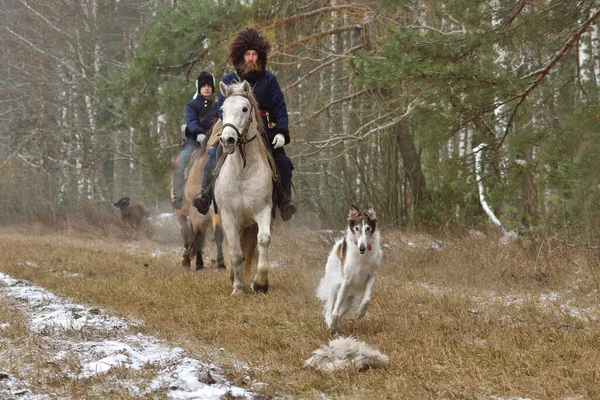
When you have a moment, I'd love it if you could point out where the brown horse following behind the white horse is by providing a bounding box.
[175,147,225,269]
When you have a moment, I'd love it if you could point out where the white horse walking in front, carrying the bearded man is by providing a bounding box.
[214,81,273,294]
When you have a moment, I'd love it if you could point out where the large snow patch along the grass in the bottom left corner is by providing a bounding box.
[0,273,254,400]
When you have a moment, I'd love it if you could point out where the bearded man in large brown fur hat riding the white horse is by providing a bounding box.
[194,27,296,221]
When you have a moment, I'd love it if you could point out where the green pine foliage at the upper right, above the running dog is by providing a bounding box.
[356,1,598,233]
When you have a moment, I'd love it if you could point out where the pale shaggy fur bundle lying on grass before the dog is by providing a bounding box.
[304,337,388,372]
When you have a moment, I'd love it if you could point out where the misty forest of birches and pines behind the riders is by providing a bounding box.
[0,0,600,239]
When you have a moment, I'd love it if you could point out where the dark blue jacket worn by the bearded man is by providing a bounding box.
[217,70,290,144]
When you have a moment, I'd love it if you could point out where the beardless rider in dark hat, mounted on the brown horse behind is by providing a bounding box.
[171,71,218,210]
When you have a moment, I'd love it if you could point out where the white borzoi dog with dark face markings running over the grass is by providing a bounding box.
[317,204,381,332]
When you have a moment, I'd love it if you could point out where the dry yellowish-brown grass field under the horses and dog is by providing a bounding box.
[0,217,600,399]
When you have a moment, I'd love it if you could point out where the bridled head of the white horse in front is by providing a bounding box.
[219,81,256,154]
